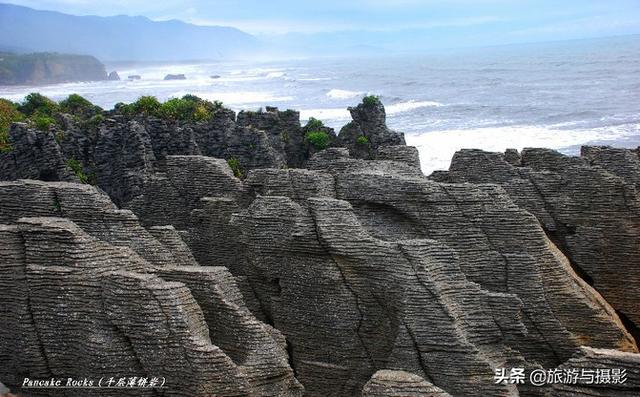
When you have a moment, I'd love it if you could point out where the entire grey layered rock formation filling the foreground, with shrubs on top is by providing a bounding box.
[0,97,640,396]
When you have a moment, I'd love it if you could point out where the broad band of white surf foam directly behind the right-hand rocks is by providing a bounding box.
[405,124,640,175]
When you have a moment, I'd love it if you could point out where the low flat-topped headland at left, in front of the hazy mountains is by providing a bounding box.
[0,53,107,85]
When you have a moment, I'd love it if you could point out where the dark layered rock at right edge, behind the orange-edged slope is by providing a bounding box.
[433,147,640,336]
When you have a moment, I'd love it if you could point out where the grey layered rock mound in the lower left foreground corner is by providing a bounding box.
[0,181,303,396]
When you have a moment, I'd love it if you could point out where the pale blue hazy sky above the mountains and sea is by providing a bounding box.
[5,0,640,46]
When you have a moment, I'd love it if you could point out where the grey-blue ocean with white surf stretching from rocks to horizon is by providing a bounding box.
[0,36,640,174]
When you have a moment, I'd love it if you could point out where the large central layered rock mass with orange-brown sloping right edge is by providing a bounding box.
[233,153,637,396]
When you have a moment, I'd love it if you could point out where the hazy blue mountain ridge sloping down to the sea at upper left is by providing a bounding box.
[0,4,260,61]
